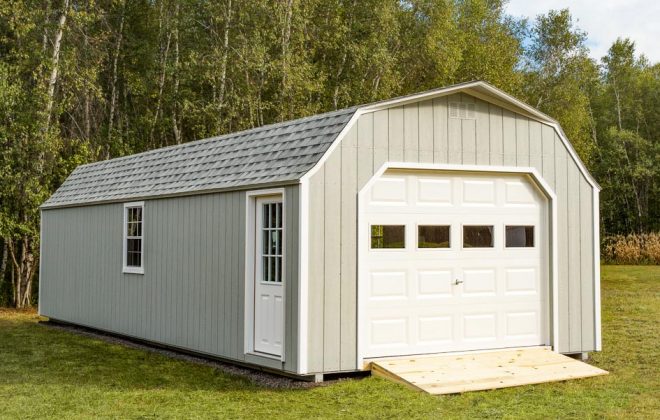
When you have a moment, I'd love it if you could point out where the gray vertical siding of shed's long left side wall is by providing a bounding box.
[39,185,299,373]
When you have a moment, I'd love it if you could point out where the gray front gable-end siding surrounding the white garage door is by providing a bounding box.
[308,93,595,373]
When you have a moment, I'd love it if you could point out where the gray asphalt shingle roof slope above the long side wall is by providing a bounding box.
[42,108,357,208]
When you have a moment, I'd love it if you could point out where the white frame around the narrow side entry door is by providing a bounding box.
[244,188,288,362]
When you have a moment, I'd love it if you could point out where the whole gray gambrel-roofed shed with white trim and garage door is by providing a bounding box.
[39,82,601,379]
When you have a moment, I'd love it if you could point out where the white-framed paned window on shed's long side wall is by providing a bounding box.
[123,203,144,274]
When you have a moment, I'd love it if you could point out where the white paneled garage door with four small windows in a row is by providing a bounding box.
[360,171,549,357]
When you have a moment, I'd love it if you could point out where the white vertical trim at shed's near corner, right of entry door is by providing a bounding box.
[298,177,309,374]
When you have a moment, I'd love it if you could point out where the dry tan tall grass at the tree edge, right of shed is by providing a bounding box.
[602,233,660,264]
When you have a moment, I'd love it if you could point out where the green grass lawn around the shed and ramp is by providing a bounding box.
[0,266,660,418]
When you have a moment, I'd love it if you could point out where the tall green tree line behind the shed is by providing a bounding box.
[0,0,660,307]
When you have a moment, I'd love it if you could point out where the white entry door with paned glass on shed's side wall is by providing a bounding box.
[254,196,284,356]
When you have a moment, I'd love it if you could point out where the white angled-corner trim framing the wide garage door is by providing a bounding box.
[356,162,559,369]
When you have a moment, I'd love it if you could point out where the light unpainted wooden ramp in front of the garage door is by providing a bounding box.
[365,347,607,395]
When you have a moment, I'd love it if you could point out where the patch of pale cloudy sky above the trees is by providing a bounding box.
[506,0,660,63]
